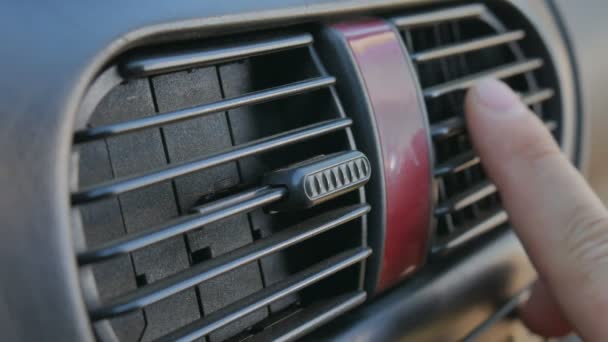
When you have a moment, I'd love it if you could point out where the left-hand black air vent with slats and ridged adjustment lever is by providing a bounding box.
[72,32,371,341]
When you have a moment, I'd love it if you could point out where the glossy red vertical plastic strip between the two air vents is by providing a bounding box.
[334,19,432,292]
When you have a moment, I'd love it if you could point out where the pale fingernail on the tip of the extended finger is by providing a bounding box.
[472,78,523,115]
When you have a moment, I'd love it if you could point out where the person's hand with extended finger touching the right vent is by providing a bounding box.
[465,79,608,341]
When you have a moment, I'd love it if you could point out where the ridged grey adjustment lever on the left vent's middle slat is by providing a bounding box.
[264,151,371,211]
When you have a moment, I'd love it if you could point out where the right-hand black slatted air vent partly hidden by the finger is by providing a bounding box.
[392,4,561,253]
